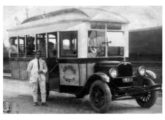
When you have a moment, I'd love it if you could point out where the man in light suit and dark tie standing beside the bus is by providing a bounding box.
[27,50,48,106]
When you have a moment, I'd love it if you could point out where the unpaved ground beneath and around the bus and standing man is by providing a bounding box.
[3,78,162,114]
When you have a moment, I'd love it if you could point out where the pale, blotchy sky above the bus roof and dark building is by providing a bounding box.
[3,6,162,47]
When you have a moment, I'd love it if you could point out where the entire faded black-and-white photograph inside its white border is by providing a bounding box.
[2,2,163,115]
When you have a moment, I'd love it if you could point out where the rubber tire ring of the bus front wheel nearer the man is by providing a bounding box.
[89,80,112,113]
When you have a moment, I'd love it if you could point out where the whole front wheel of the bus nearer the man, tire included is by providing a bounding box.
[90,80,111,113]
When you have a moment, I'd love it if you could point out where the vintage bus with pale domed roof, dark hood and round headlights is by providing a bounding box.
[8,8,161,112]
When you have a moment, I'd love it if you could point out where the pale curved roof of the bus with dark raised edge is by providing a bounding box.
[8,8,129,36]
